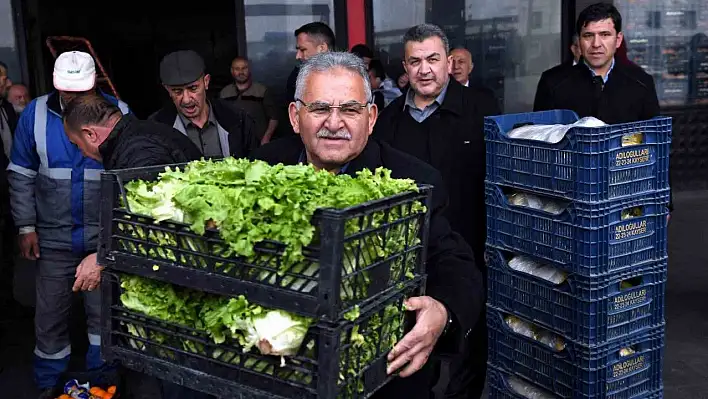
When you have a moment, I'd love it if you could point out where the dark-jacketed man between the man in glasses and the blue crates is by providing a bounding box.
[374,24,500,398]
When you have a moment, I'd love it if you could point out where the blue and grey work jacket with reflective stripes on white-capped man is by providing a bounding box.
[7,92,130,253]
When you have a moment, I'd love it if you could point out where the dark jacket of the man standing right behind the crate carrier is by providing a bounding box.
[373,77,501,267]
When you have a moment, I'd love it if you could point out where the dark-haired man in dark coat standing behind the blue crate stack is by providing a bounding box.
[534,3,660,124]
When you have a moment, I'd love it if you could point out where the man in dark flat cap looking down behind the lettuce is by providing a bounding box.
[150,50,258,158]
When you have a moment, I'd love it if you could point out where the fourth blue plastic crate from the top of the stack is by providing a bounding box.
[487,306,664,399]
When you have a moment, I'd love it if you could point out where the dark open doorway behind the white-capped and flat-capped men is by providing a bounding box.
[24,0,237,118]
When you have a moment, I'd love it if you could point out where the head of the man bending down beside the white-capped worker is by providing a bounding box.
[63,94,123,161]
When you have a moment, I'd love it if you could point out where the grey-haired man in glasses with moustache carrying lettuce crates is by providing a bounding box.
[252,52,483,399]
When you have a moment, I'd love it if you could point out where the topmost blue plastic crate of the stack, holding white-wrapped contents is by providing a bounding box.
[484,110,671,202]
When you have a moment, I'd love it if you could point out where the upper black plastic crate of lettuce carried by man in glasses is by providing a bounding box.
[98,164,432,322]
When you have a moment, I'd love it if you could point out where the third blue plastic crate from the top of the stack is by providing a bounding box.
[487,247,667,345]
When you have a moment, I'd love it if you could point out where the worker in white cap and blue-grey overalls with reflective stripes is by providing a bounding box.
[8,51,129,398]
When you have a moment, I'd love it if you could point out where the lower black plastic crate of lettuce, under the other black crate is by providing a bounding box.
[101,273,425,399]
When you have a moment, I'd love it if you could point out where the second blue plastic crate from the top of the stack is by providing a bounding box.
[485,182,669,276]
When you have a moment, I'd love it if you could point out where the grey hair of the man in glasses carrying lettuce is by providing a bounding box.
[295,51,372,108]
